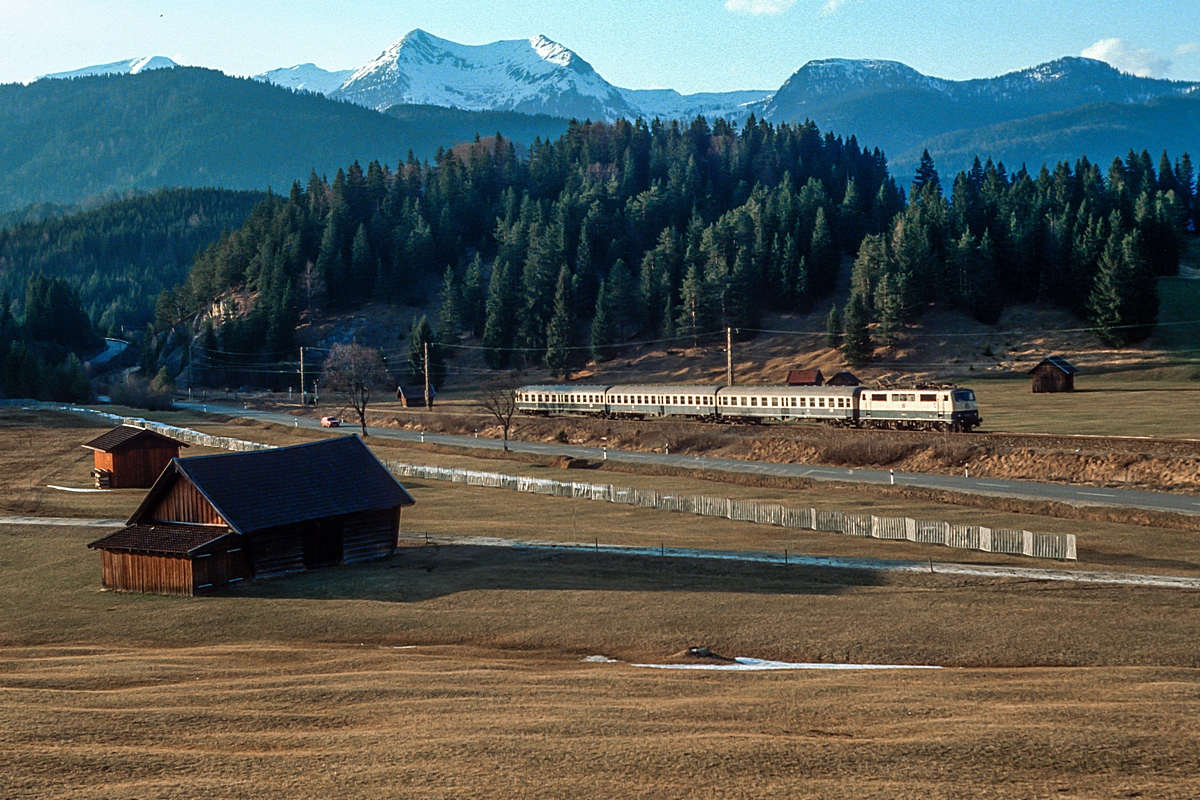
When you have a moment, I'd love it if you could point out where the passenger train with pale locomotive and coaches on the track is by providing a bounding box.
[516,384,983,432]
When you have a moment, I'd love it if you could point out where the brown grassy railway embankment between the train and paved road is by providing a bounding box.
[370,411,1200,494]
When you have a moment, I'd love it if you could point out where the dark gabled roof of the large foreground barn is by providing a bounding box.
[130,435,415,534]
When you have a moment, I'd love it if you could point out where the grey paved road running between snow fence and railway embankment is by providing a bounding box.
[176,403,1200,516]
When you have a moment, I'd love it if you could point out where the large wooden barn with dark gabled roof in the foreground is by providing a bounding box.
[88,435,414,596]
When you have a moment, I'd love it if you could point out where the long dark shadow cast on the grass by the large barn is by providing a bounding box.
[231,545,886,602]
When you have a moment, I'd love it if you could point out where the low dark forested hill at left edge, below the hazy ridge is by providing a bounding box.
[0,188,265,332]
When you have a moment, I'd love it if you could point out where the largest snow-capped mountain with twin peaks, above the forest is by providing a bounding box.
[330,30,637,120]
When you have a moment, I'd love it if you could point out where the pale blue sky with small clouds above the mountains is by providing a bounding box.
[0,0,1200,92]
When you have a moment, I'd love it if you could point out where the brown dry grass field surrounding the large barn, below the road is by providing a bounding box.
[0,414,1200,799]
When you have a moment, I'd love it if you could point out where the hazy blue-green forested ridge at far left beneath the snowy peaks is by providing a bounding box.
[0,67,565,211]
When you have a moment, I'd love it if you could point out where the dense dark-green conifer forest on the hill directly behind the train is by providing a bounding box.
[160,120,1194,383]
